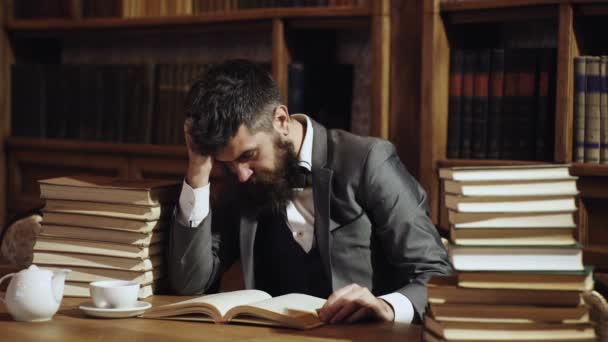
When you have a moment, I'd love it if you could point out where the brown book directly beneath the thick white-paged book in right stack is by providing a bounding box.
[457,267,593,291]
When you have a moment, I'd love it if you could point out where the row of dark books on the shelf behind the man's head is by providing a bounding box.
[11,63,353,145]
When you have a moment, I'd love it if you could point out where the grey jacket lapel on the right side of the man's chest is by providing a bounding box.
[311,119,333,285]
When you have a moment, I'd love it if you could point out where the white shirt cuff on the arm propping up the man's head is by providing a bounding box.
[178,180,211,227]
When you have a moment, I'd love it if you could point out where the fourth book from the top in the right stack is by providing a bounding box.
[448,210,576,228]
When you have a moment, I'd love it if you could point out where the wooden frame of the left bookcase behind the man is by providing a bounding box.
[0,0,400,227]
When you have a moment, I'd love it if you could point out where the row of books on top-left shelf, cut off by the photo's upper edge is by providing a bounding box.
[14,0,369,19]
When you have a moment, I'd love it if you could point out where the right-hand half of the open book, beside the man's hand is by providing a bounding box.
[225,293,325,329]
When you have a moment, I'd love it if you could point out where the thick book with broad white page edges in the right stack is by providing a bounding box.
[448,244,584,271]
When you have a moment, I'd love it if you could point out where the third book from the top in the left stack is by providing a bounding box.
[42,211,169,233]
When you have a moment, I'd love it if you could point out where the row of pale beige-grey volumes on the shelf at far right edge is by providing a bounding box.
[574,56,608,164]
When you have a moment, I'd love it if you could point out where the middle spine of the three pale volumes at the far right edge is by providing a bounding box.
[585,57,601,163]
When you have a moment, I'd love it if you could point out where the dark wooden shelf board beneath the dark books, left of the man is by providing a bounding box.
[6,137,188,159]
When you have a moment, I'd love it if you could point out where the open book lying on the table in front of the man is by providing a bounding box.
[142,290,325,329]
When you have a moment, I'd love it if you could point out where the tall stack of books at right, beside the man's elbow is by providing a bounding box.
[424,165,596,341]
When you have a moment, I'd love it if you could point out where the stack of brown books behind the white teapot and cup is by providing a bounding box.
[33,176,180,298]
